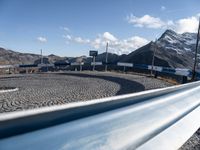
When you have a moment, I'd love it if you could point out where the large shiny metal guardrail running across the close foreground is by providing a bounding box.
[0,82,200,150]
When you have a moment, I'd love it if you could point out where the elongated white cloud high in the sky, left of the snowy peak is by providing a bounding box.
[127,14,166,29]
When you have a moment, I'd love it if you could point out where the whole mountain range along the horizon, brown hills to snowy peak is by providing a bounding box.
[0,30,200,69]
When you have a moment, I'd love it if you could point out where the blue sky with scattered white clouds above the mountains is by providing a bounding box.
[0,0,200,56]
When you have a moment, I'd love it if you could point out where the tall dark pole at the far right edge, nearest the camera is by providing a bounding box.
[192,18,200,81]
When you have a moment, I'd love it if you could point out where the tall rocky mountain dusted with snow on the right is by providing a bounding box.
[121,30,200,69]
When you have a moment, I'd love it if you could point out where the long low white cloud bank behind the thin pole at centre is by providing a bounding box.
[63,32,149,54]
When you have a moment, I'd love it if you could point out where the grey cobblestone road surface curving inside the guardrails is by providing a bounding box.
[0,72,171,113]
